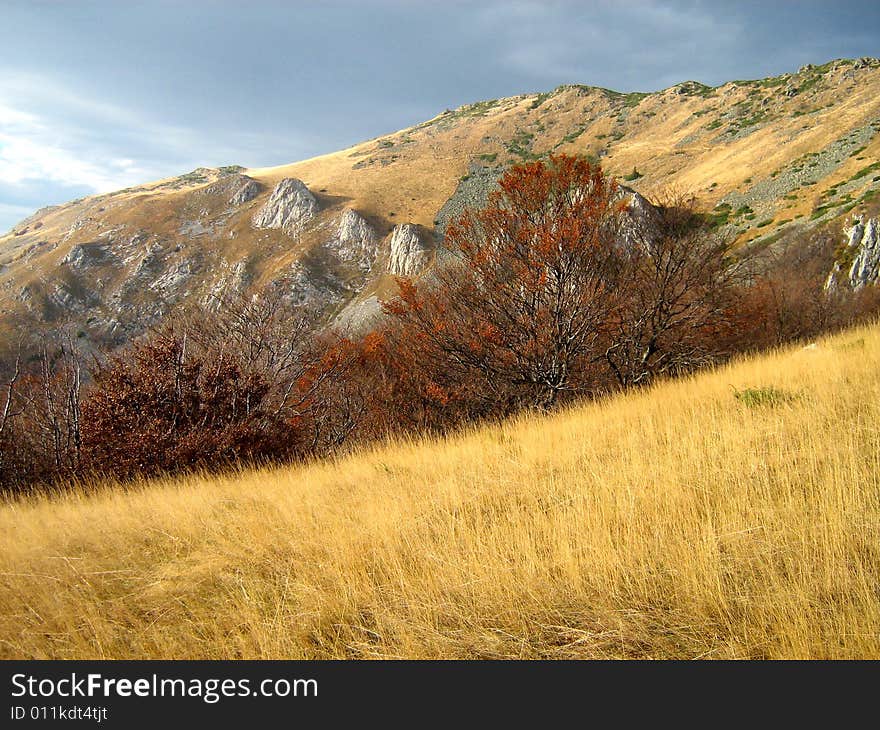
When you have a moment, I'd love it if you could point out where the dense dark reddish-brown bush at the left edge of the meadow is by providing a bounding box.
[82,333,286,477]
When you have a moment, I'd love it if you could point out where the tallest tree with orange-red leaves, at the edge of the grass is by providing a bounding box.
[387,155,626,408]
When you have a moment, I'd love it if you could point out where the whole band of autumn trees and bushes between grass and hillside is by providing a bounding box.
[0,155,880,492]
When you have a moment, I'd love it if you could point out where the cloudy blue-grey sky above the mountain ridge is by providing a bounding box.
[0,0,880,231]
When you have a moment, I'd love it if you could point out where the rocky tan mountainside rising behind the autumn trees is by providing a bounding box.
[0,59,880,342]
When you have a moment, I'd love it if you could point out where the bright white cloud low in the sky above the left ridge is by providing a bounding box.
[0,70,320,230]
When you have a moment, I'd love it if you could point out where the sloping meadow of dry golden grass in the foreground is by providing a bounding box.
[0,326,880,658]
